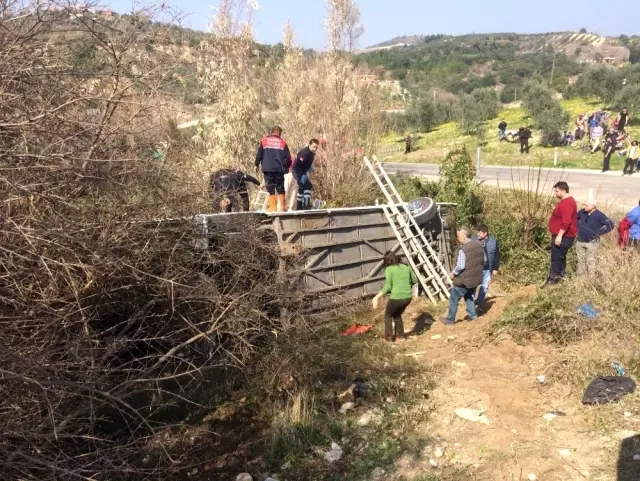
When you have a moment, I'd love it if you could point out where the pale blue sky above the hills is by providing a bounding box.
[103,0,640,49]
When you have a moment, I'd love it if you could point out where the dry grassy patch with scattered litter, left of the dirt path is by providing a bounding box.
[242,313,434,481]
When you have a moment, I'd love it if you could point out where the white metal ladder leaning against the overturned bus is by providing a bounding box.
[364,155,451,303]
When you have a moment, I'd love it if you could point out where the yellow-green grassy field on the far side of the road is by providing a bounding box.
[382,99,640,170]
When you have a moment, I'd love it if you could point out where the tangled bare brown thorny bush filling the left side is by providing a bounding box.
[0,1,279,481]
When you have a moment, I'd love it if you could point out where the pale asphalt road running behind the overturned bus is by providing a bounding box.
[384,163,640,210]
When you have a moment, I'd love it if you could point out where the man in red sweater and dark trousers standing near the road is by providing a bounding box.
[542,181,578,287]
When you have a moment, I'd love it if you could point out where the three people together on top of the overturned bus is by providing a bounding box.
[209,126,320,212]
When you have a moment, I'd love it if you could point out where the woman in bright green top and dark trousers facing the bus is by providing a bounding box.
[373,251,418,341]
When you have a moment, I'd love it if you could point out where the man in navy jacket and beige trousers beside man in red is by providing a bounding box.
[576,196,615,276]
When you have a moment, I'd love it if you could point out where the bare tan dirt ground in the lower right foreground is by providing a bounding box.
[382,288,640,481]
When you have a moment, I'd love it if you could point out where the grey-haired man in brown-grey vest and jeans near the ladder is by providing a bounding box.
[440,226,484,324]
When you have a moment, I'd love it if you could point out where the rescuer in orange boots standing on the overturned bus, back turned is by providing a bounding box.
[256,126,291,212]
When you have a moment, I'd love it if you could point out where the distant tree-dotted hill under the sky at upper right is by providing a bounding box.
[355,32,640,102]
